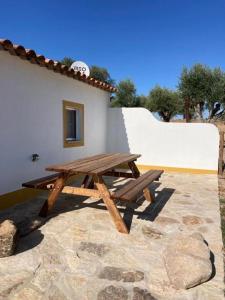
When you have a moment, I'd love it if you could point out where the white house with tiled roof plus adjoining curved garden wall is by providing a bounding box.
[0,40,219,209]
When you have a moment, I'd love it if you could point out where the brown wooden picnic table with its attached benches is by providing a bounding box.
[22,153,163,233]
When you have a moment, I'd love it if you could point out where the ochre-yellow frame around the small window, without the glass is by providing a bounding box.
[63,100,84,148]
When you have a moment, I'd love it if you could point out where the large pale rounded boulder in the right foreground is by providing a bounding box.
[163,233,212,289]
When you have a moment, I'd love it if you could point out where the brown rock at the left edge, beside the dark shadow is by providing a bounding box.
[0,220,17,257]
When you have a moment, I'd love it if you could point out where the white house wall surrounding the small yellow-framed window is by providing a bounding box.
[0,51,110,194]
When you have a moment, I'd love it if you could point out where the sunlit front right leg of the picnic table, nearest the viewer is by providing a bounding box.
[94,176,129,233]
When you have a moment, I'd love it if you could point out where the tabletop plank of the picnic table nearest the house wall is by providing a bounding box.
[46,153,112,172]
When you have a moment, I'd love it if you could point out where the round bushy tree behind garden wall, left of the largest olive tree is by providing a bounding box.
[145,86,183,122]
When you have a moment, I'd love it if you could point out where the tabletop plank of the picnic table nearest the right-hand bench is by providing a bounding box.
[85,154,140,175]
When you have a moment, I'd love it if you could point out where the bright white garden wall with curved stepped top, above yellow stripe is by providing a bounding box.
[107,108,219,170]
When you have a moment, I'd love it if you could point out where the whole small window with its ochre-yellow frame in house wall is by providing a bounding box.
[63,100,84,147]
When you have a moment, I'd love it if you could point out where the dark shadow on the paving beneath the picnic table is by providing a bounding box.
[0,182,175,254]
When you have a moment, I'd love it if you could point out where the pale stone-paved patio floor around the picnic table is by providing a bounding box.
[0,173,224,300]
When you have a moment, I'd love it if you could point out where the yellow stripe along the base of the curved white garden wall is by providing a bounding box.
[137,164,218,174]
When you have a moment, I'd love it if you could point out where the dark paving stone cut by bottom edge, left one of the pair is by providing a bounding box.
[97,285,128,300]
